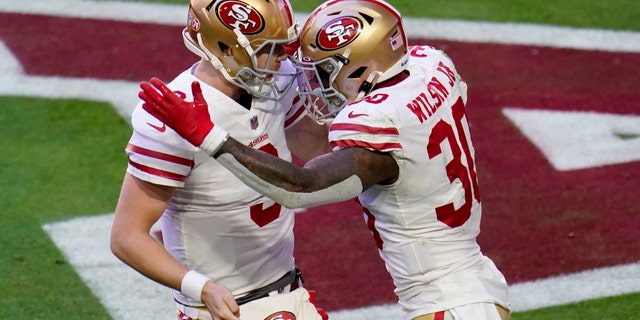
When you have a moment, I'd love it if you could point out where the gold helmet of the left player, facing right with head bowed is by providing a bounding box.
[182,0,299,100]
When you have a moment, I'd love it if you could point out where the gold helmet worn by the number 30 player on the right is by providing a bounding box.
[294,0,409,122]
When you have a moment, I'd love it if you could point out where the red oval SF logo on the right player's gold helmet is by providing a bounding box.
[316,17,362,50]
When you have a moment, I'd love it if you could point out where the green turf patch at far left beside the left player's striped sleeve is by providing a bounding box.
[0,97,131,319]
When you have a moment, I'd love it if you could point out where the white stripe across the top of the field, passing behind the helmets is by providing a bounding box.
[0,0,640,52]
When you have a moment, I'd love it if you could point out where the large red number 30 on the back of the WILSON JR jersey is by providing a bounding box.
[427,99,480,228]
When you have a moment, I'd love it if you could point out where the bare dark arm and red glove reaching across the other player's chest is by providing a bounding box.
[139,79,399,196]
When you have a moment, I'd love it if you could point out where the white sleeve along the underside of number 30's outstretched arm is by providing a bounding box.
[216,153,362,208]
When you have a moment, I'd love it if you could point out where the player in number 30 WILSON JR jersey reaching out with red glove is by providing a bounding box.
[140,0,510,320]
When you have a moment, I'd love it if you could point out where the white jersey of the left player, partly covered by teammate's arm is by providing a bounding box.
[126,63,305,305]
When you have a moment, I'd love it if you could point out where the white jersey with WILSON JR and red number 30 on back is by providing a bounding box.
[329,46,508,319]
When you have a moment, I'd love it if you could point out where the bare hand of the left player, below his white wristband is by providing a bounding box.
[202,282,240,320]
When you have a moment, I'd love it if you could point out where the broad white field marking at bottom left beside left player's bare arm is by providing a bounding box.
[42,213,176,320]
